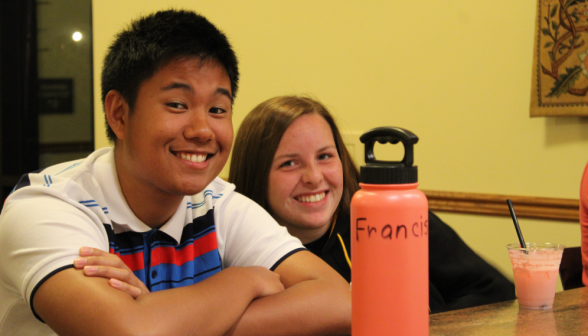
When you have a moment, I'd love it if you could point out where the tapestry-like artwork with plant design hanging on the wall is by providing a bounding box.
[530,0,588,117]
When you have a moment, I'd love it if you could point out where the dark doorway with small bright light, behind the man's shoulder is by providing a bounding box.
[0,0,94,211]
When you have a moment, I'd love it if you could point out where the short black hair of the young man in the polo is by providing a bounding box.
[102,10,239,143]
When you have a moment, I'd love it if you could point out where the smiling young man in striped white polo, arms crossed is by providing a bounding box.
[0,10,351,335]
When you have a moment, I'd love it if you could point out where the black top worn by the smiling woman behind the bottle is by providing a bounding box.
[304,211,516,314]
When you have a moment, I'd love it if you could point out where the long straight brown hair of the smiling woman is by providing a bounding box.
[229,96,359,213]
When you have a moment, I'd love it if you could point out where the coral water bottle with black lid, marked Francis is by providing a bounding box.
[351,127,429,336]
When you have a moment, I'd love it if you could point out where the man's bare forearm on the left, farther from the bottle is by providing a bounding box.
[34,268,279,335]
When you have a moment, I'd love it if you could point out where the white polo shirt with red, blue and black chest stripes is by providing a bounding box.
[0,148,304,335]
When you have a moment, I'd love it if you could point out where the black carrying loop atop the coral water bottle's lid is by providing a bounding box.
[359,126,419,167]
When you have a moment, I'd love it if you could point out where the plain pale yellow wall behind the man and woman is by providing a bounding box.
[93,0,588,290]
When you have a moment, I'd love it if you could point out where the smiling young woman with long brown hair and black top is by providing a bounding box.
[229,96,515,313]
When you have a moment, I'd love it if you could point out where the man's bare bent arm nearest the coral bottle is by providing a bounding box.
[228,251,351,336]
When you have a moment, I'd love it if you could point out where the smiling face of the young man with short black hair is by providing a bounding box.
[117,58,233,200]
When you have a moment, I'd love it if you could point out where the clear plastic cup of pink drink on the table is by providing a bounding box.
[506,243,565,309]
